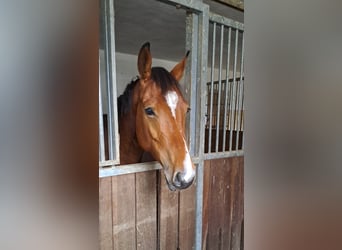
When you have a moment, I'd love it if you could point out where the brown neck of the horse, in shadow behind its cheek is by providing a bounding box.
[119,94,144,164]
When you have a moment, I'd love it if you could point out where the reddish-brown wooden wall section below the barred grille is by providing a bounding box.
[202,157,243,250]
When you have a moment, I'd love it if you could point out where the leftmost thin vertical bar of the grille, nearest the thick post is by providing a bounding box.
[208,22,216,153]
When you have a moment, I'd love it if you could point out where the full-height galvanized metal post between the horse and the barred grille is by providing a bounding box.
[195,4,209,250]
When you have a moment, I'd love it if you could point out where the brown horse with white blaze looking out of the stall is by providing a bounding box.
[118,43,196,191]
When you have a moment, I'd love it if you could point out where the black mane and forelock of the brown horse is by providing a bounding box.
[118,67,180,117]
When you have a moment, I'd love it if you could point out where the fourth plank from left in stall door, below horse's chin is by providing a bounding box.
[158,170,179,250]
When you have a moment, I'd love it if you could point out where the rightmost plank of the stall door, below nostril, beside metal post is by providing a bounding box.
[178,179,196,250]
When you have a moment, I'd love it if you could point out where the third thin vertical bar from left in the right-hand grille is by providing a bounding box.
[222,27,232,151]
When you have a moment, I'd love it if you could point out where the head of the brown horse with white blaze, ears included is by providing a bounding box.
[133,43,196,190]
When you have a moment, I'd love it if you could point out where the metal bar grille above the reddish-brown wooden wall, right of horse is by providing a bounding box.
[205,13,244,158]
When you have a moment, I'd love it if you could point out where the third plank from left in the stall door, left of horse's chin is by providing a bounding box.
[136,171,157,250]
